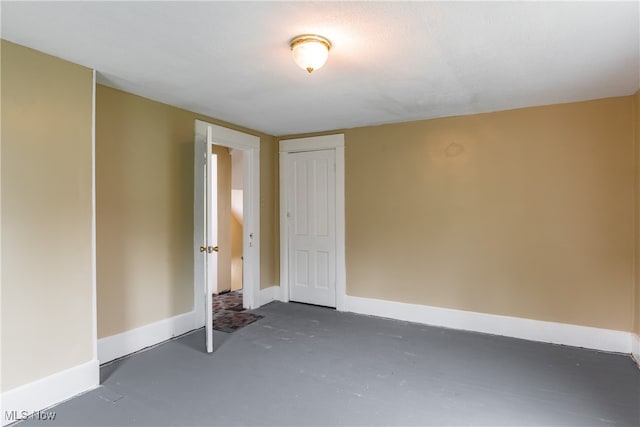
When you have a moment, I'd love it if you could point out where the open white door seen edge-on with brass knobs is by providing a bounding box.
[200,129,218,353]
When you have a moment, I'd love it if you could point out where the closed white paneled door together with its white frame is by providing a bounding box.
[280,134,346,311]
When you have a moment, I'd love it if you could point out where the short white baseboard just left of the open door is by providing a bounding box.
[98,311,196,364]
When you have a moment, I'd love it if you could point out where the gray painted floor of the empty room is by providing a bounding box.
[20,302,640,427]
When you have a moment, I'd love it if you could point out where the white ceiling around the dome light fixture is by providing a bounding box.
[0,1,640,135]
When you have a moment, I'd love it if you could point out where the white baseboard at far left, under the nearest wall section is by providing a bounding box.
[0,359,100,426]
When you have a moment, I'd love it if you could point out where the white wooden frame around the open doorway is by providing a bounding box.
[193,120,260,327]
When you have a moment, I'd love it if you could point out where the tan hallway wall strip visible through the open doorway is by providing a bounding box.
[213,145,231,293]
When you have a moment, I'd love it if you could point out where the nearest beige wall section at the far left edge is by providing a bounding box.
[0,40,94,392]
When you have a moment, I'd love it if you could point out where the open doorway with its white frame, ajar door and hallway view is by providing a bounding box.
[193,120,260,352]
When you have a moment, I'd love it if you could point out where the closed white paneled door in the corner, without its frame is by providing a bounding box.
[287,150,336,307]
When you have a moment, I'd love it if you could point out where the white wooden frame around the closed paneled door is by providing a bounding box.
[279,133,346,311]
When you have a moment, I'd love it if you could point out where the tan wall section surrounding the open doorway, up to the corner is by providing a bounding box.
[96,85,276,338]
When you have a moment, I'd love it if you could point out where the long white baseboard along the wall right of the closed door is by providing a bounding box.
[345,295,632,354]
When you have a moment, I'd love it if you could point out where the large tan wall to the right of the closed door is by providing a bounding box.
[345,97,634,331]
